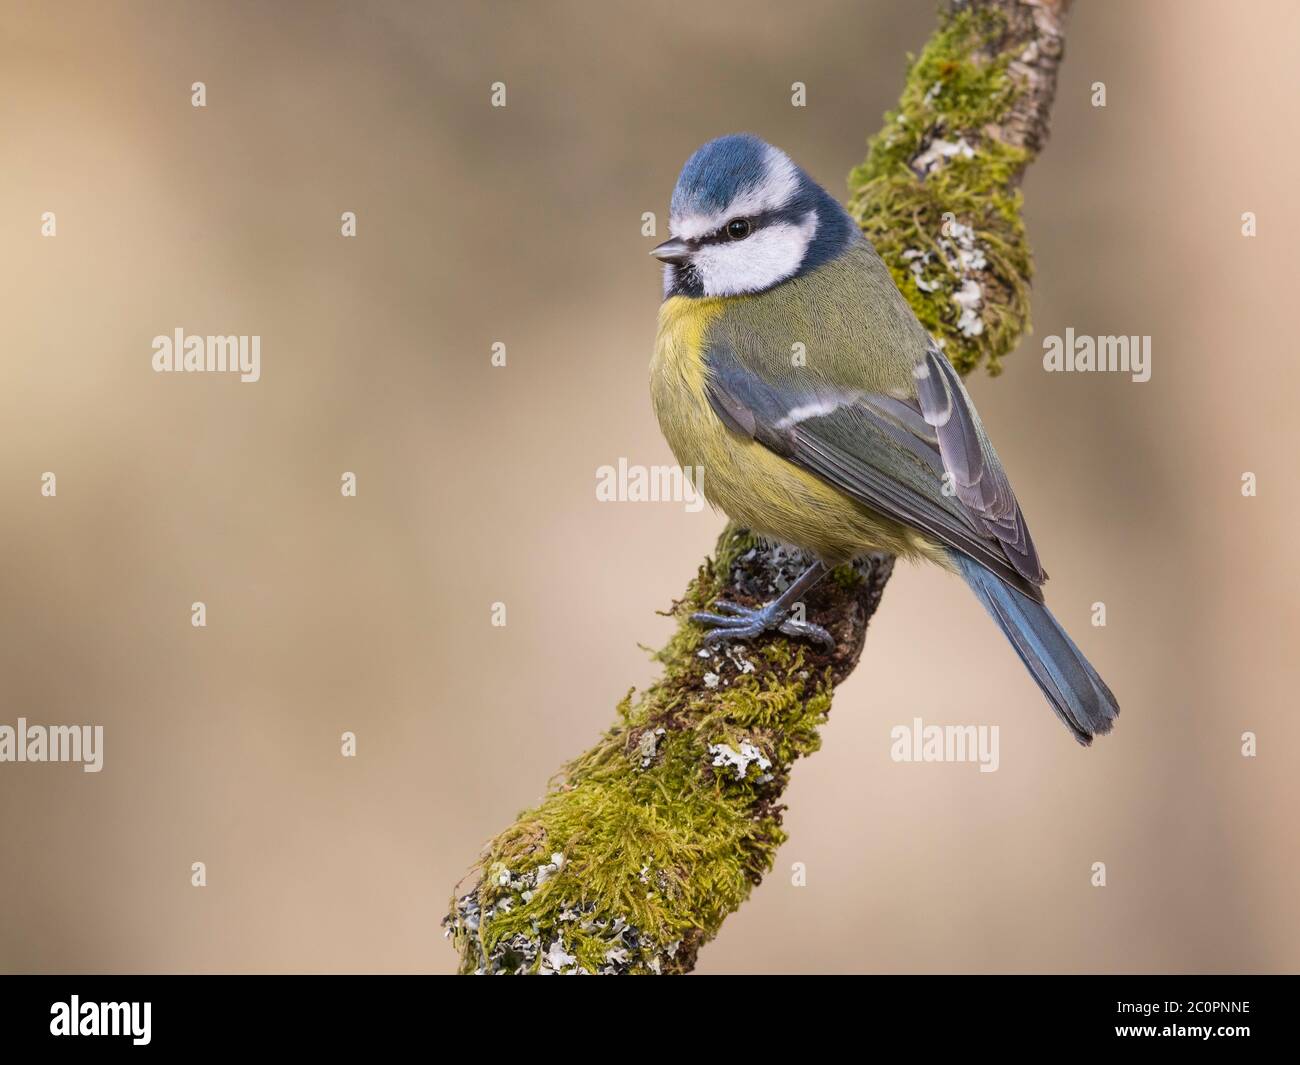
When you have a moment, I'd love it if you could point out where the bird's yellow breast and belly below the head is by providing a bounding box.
[650,296,918,564]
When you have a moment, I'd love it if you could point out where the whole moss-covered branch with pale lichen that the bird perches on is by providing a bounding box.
[443,0,1069,974]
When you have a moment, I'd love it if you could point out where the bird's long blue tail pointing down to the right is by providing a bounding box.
[953,551,1119,746]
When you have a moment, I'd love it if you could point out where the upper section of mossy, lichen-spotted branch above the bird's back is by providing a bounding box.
[848,0,1062,375]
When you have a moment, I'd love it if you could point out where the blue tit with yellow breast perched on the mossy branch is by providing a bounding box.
[650,134,1119,745]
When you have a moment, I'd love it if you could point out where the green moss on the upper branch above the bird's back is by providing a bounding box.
[849,9,1032,375]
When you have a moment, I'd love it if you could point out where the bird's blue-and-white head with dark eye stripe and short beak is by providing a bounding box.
[650,133,861,298]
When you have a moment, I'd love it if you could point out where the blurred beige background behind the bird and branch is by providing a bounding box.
[0,0,1300,973]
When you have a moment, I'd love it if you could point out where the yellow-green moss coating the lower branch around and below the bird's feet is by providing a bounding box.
[449,527,832,973]
